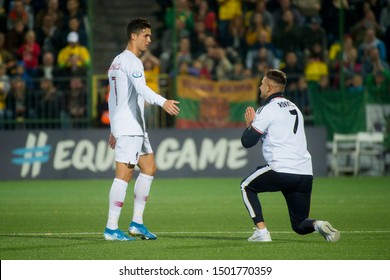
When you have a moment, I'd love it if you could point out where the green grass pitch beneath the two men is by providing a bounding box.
[0,176,390,260]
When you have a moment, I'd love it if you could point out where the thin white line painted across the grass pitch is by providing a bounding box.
[0,230,390,236]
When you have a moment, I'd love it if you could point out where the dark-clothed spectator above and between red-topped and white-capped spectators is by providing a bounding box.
[36,13,63,56]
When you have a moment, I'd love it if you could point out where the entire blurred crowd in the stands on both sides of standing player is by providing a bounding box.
[0,0,390,129]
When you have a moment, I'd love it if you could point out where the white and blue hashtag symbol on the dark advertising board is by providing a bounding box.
[12,132,51,178]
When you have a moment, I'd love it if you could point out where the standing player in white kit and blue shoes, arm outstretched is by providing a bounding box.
[104,18,180,241]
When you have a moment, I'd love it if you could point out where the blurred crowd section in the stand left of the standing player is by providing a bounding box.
[0,0,90,129]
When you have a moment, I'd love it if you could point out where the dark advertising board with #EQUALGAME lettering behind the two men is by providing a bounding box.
[0,128,327,180]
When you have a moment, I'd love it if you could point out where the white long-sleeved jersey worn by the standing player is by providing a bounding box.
[108,50,166,136]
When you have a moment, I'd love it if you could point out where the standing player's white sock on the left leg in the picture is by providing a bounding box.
[107,178,128,229]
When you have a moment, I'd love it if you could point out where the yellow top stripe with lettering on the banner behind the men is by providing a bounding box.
[177,76,259,103]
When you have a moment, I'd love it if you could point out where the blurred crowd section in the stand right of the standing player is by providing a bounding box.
[155,0,390,114]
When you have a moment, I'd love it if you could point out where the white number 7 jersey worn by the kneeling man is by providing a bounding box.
[252,96,313,175]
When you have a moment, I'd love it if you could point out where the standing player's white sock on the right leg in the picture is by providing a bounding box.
[133,173,153,224]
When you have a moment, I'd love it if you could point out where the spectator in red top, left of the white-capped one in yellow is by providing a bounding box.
[17,30,41,77]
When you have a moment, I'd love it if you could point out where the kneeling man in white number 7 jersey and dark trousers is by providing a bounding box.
[241,69,340,242]
